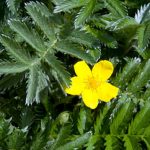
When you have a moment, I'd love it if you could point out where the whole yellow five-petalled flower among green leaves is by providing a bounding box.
[65,60,119,109]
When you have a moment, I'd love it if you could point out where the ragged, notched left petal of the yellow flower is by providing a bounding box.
[65,77,84,95]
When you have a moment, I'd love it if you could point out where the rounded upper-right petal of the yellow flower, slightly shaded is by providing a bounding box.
[92,60,114,81]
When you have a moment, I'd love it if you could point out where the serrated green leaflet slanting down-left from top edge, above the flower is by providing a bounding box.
[75,0,96,28]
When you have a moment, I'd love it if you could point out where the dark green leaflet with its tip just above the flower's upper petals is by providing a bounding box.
[55,40,95,64]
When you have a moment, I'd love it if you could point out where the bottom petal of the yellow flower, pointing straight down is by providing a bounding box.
[82,89,98,109]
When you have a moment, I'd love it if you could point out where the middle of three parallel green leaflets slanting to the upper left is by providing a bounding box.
[9,20,47,52]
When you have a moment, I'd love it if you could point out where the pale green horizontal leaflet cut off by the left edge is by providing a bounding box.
[0,62,29,74]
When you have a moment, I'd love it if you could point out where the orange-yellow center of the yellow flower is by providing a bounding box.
[87,77,99,89]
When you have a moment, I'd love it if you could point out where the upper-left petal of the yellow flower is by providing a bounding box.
[74,61,92,79]
